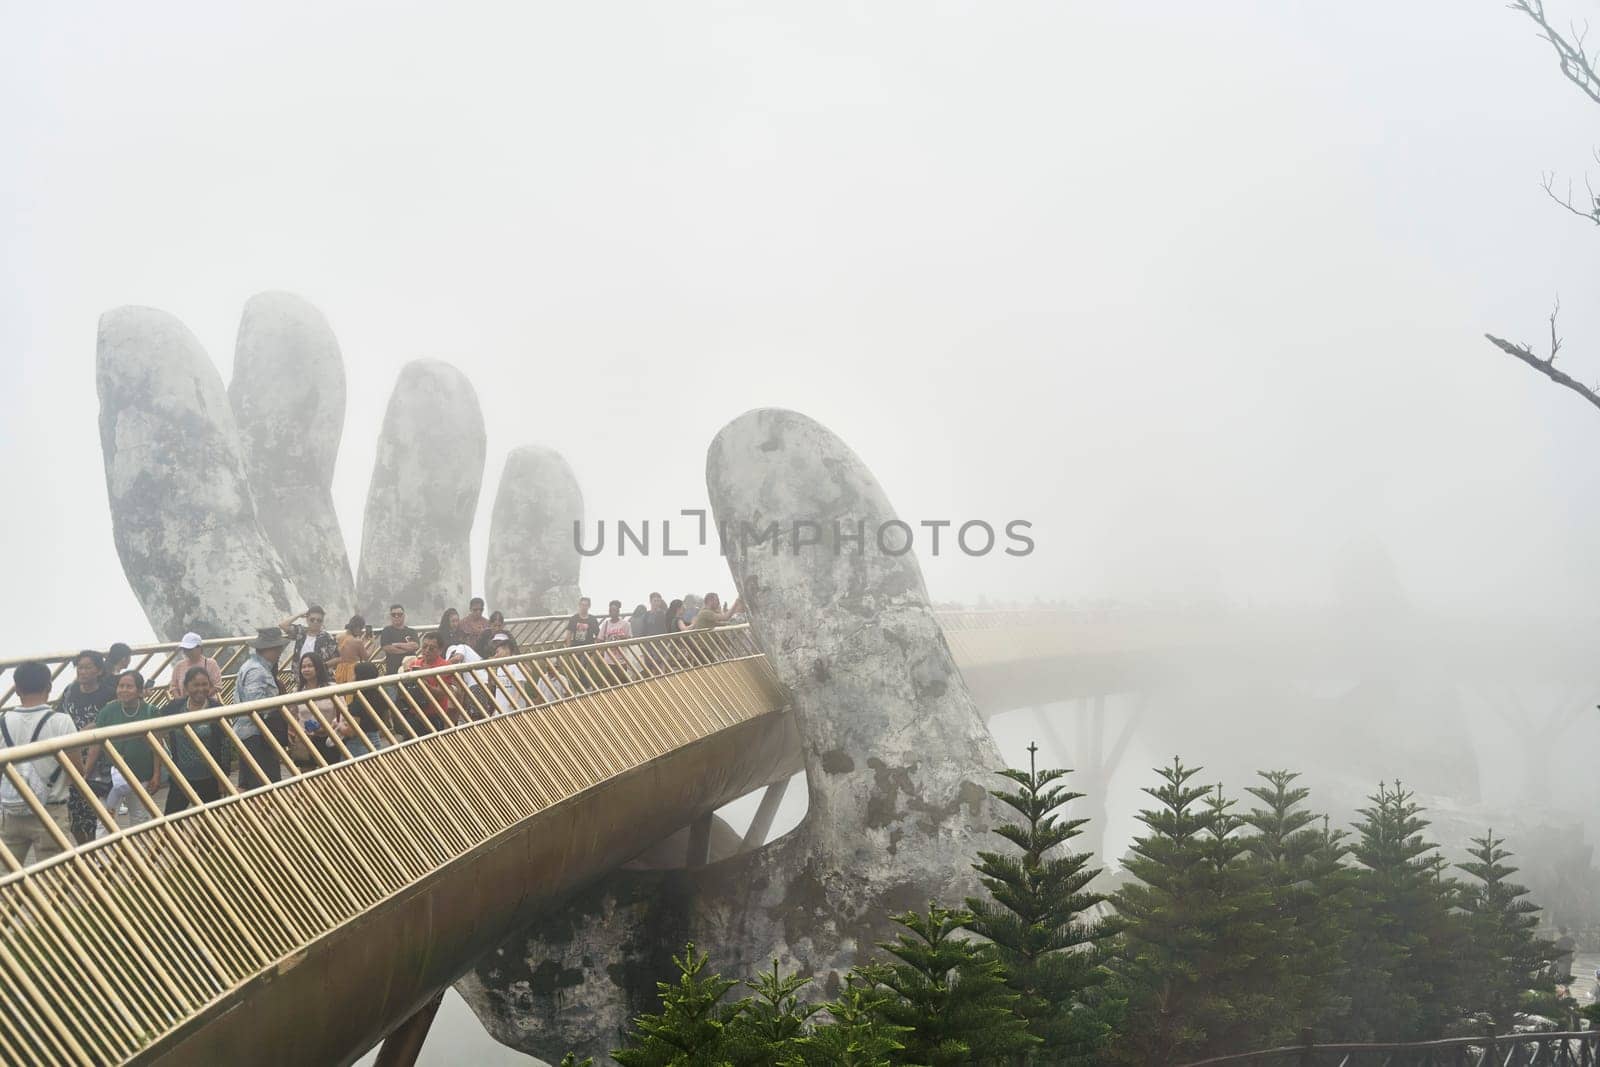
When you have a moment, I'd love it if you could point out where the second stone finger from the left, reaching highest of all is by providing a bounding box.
[227,293,353,617]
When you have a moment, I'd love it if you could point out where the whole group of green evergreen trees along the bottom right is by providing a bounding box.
[601,747,1600,1067]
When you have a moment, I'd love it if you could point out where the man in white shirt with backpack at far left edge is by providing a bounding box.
[0,662,77,865]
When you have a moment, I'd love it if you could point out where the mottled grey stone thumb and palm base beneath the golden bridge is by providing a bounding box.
[459,410,1000,1062]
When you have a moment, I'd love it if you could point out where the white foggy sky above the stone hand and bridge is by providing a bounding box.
[0,0,1600,653]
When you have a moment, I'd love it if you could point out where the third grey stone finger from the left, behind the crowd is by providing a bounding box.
[355,360,488,619]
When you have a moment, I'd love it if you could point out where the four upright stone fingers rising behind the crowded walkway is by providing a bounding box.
[96,293,582,640]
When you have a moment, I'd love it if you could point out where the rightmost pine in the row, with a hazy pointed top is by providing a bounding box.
[1456,830,1571,1029]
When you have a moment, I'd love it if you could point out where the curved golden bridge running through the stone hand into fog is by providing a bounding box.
[0,613,1593,1067]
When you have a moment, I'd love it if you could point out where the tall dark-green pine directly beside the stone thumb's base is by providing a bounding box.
[966,744,1112,1064]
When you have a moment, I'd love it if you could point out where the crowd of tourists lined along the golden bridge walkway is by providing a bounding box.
[0,593,744,864]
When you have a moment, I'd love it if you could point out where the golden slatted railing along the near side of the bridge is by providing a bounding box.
[0,625,784,1065]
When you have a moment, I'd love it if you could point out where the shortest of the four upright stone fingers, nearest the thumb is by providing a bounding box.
[483,445,584,616]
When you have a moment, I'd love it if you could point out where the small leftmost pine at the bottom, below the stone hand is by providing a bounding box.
[611,942,742,1067]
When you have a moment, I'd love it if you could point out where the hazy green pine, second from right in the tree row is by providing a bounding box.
[1339,782,1467,1041]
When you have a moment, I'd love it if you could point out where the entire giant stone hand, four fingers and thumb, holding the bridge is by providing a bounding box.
[98,294,998,1061]
